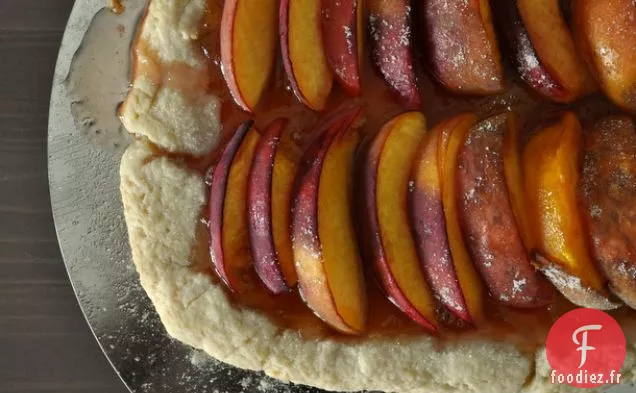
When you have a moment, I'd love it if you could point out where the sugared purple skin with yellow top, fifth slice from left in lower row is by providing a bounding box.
[409,124,471,322]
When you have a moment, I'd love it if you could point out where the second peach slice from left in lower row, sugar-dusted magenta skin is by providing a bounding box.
[247,119,299,294]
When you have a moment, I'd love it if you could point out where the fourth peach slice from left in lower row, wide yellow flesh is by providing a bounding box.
[363,112,437,332]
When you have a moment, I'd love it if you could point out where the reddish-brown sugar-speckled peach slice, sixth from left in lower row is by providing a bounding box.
[457,113,554,308]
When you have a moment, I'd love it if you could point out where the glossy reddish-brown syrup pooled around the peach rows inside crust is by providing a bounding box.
[124,0,634,351]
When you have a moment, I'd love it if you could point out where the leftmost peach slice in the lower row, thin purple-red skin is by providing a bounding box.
[208,121,260,293]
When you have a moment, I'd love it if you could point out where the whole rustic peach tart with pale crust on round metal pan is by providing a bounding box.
[120,0,636,393]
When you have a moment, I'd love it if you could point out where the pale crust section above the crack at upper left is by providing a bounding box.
[121,0,221,155]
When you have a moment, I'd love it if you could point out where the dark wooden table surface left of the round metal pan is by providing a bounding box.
[0,0,127,393]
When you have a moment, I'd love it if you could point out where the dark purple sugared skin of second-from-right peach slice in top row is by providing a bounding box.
[493,0,574,102]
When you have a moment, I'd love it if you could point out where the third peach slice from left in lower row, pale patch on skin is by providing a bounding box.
[292,111,367,334]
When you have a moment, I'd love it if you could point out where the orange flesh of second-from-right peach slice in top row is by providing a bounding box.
[516,0,596,102]
